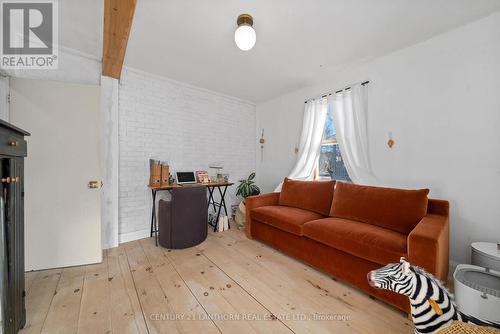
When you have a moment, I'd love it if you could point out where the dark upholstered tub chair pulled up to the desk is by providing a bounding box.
[158,186,208,249]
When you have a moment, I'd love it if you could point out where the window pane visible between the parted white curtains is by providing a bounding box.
[318,107,351,182]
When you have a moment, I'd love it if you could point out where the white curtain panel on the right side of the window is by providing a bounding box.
[330,84,376,184]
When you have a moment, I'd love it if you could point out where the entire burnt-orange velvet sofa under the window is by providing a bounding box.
[245,179,449,312]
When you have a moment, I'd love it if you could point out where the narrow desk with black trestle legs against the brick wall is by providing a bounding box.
[148,182,234,246]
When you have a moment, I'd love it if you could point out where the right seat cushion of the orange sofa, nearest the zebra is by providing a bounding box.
[303,218,407,264]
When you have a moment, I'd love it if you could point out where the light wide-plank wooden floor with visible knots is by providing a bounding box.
[21,229,413,334]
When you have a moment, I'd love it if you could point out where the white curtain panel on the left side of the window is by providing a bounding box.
[275,98,328,191]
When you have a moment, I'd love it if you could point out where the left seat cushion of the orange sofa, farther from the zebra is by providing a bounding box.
[250,205,324,236]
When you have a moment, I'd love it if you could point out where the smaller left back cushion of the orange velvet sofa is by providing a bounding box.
[279,178,335,216]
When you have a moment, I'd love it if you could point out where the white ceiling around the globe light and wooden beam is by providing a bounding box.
[59,0,500,103]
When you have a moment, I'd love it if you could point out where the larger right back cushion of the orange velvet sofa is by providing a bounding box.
[330,182,429,234]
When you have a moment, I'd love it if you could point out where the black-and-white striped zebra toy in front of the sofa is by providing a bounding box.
[368,257,500,333]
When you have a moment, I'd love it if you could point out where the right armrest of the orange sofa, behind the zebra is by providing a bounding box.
[408,214,450,283]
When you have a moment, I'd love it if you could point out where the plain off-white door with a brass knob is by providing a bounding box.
[10,78,102,270]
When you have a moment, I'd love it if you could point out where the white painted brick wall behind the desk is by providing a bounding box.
[119,69,256,234]
